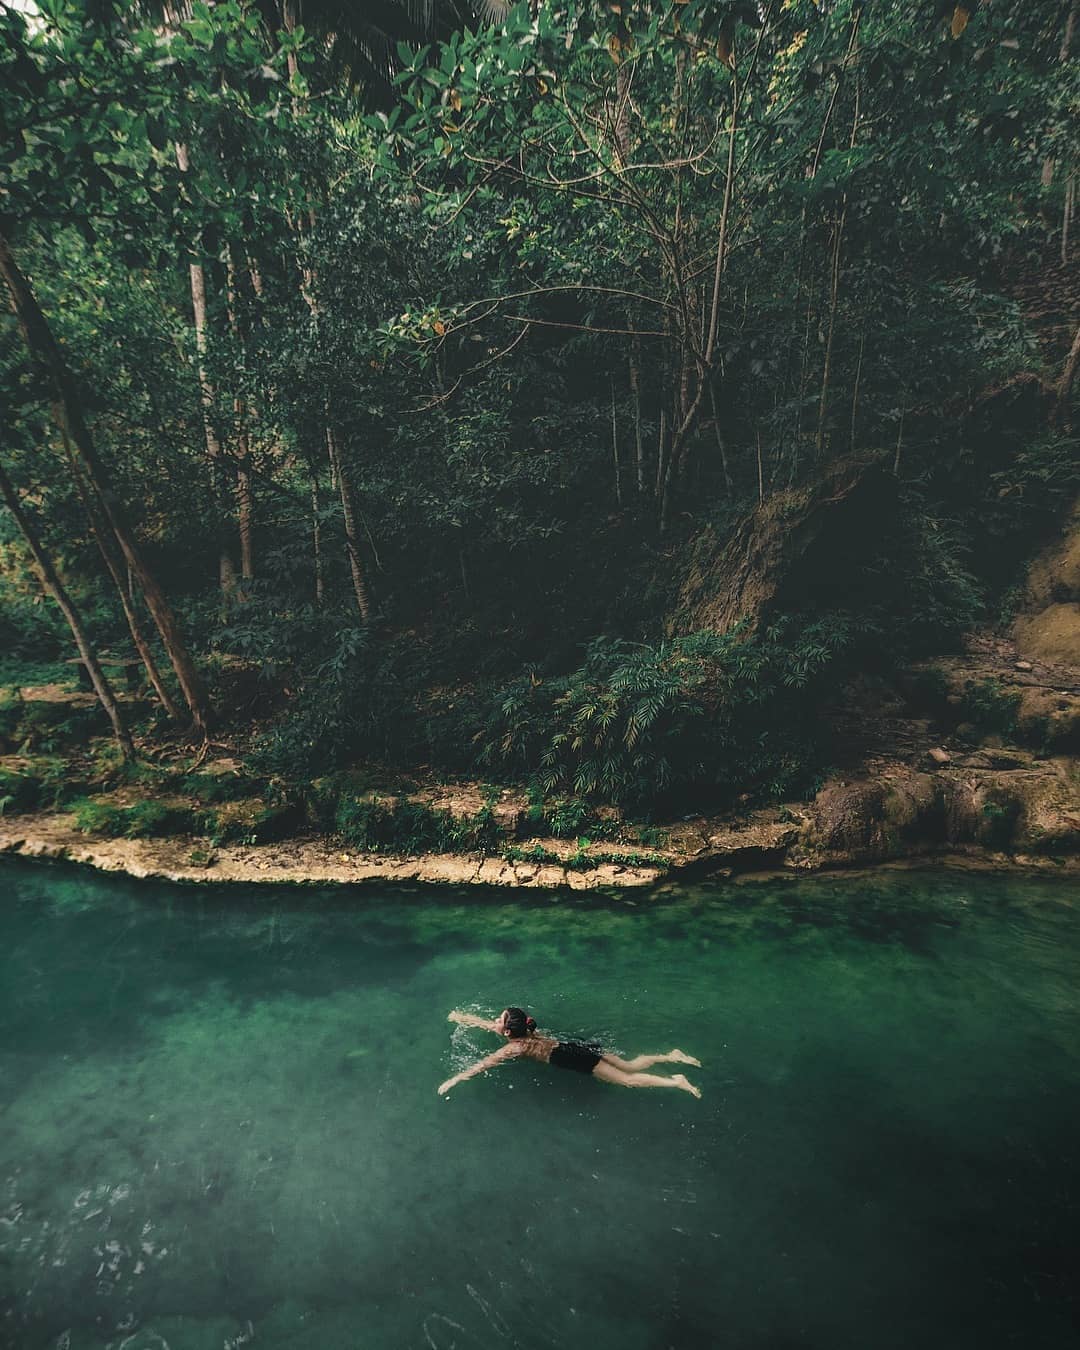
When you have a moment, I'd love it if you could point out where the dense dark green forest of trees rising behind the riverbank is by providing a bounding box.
[0,0,1080,864]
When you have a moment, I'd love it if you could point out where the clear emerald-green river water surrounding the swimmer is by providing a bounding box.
[0,863,1080,1350]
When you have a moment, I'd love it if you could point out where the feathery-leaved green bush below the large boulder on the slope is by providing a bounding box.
[482,616,851,810]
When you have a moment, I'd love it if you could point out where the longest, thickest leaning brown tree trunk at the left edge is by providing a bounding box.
[0,235,211,738]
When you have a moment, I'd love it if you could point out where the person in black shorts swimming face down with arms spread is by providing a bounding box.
[439,1008,701,1098]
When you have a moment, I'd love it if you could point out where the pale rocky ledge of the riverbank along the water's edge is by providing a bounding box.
[0,748,1080,890]
